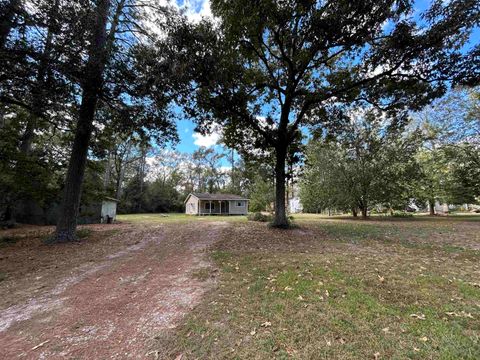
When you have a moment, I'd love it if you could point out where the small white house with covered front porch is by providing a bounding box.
[185,193,248,215]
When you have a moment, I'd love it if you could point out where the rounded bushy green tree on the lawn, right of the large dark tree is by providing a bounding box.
[300,110,421,214]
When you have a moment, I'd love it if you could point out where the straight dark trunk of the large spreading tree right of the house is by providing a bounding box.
[273,146,288,228]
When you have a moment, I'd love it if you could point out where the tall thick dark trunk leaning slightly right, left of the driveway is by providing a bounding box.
[55,0,113,242]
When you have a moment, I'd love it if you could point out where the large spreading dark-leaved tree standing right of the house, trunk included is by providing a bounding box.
[178,0,480,227]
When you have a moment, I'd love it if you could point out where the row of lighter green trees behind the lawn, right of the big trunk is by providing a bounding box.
[300,88,480,217]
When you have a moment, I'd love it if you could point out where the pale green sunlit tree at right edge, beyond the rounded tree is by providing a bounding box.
[415,88,480,208]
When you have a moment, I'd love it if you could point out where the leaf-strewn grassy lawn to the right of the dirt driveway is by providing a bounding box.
[145,215,480,359]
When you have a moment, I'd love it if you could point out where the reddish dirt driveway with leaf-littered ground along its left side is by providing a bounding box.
[0,222,228,359]
